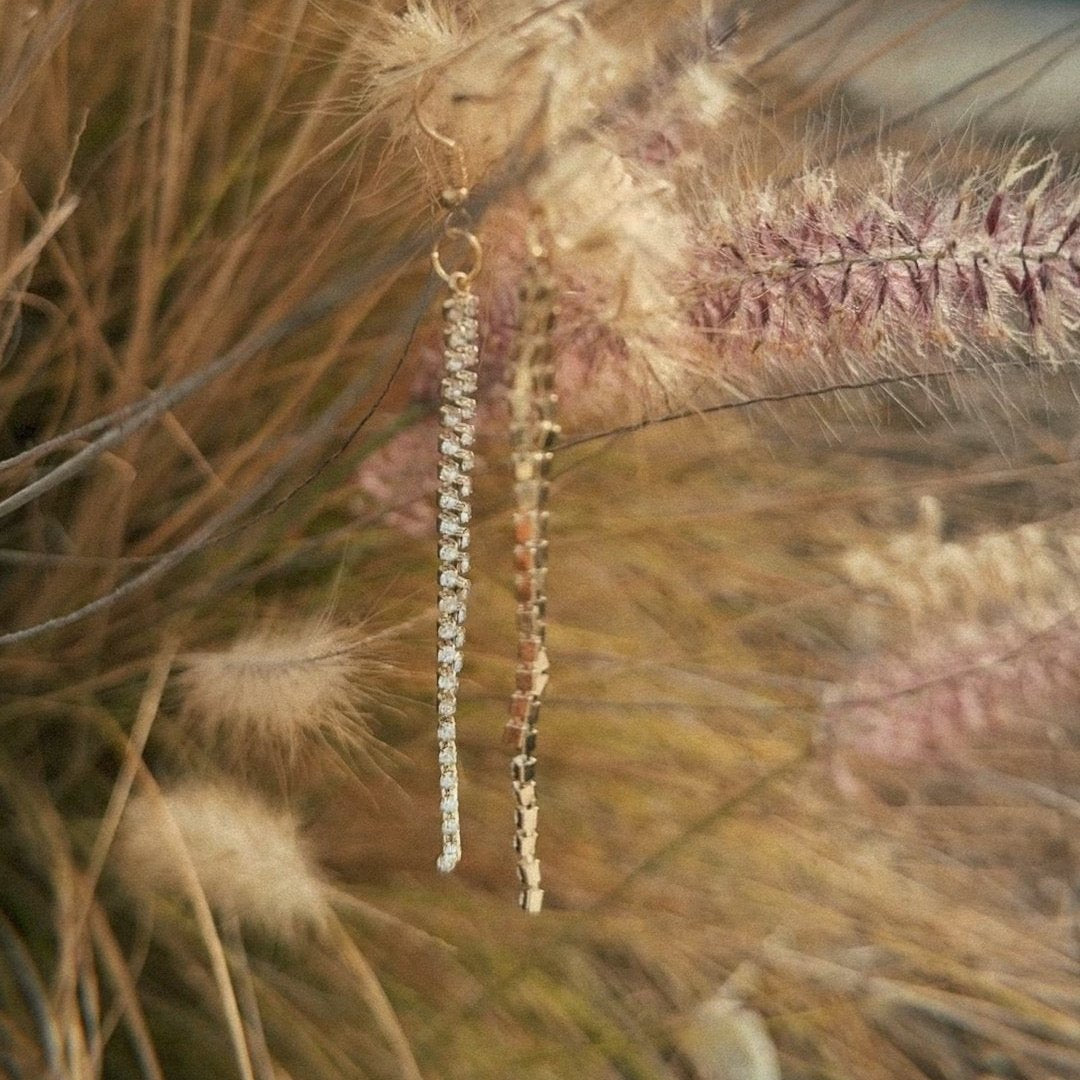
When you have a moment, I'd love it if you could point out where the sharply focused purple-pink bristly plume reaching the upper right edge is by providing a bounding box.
[688,150,1080,390]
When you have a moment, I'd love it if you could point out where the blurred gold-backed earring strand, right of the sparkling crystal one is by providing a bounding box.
[507,240,558,914]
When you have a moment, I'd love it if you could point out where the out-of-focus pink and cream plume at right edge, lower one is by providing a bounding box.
[822,498,1080,775]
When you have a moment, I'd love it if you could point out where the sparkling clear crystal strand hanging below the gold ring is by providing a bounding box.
[435,284,480,873]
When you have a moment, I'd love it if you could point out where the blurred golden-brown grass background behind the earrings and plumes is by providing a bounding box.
[0,0,1080,1080]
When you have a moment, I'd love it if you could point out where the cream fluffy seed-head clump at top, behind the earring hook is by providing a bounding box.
[356,0,730,420]
